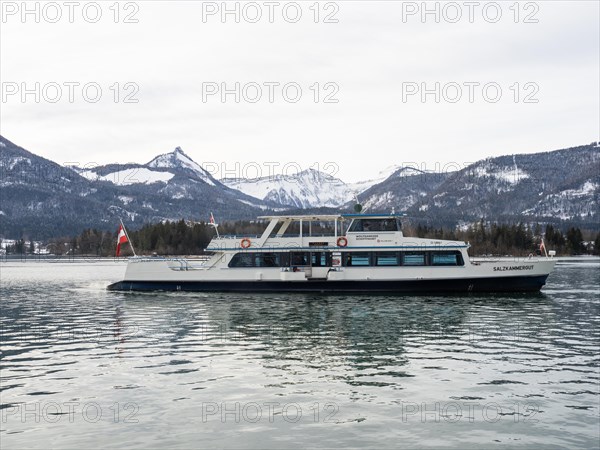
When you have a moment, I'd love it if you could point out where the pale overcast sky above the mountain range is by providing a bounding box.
[0,1,600,181]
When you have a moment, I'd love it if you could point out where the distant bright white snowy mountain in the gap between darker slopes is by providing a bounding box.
[221,169,354,208]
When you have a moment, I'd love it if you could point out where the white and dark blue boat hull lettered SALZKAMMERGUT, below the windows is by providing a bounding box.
[109,258,556,293]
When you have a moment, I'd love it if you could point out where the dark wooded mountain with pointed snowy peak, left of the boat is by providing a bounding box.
[0,136,270,239]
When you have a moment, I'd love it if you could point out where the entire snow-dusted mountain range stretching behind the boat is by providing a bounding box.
[0,136,600,239]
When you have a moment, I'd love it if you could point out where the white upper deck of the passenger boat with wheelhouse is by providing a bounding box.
[207,214,467,251]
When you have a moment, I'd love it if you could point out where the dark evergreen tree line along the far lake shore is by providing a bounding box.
[3,219,600,257]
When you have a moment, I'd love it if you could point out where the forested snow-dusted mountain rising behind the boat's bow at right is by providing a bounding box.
[361,144,600,223]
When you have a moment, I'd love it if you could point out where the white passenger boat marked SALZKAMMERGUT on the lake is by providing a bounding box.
[108,214,556,293]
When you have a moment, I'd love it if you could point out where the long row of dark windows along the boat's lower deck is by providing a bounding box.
[229,251,465,267]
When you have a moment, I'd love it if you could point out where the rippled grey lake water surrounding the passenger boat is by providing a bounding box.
[0,258,600,449]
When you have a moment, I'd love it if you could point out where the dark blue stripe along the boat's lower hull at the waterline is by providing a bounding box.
[107,275,548,293]
